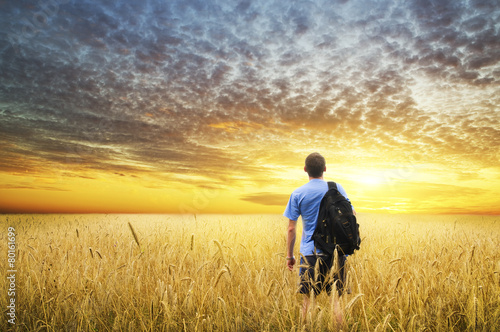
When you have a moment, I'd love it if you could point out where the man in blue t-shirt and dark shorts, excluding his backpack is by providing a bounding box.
[283,152,356,324]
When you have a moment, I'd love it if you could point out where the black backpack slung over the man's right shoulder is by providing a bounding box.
[312,182,361,255]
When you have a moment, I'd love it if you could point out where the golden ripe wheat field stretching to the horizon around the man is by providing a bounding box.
[0,214,500,331]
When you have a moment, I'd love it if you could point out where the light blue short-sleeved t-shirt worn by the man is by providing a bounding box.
[283,179,349,256]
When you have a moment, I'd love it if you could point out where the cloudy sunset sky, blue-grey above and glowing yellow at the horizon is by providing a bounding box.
[0,0,500,214]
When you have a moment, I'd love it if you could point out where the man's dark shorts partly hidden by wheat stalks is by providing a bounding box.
[298,255,346,296]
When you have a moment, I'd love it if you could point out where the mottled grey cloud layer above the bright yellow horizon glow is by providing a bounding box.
[0,0,500,187]
